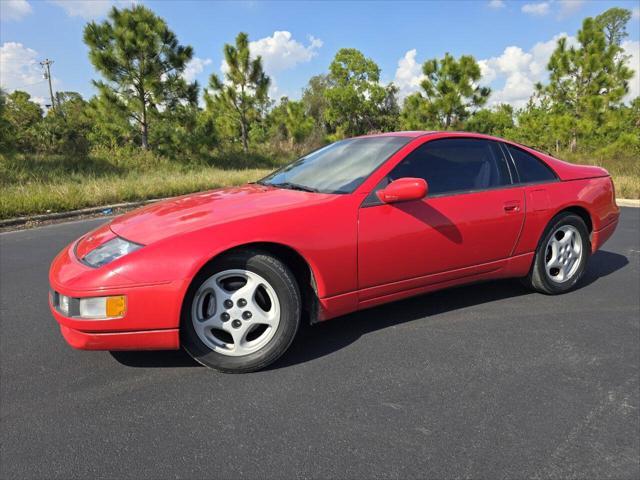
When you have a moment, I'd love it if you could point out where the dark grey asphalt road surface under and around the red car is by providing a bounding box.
[0,209,640,478]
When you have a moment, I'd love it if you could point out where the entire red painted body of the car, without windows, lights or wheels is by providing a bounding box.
[49,132,619,349]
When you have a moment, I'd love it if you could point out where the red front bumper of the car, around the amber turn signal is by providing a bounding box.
[49,239,188,350]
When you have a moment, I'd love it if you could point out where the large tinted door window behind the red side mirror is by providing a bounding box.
[388,138,511,196]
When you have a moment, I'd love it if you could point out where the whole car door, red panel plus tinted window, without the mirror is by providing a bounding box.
[358,137,524,300]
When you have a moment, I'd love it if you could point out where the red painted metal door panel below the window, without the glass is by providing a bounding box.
[358,188,524,292]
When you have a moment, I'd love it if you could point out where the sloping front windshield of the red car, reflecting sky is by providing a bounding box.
[259,137,411,193]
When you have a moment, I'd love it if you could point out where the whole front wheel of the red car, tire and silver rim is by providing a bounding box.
[181,251,301,373]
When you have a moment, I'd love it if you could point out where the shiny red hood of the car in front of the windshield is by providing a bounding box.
[110,184,335,245]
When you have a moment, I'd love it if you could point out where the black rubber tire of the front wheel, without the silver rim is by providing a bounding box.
[180,250,301,373]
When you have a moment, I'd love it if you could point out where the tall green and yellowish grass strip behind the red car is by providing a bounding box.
[0,149,640,219]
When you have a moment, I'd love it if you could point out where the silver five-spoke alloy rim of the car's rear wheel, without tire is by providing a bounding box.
[545,225,583,283]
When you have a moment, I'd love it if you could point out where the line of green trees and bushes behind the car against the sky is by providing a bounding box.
[0,5,640,159]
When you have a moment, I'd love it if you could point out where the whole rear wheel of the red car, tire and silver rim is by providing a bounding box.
[524,212,591,295]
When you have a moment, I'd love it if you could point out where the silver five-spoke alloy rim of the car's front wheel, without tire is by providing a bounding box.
[191,269,280,357]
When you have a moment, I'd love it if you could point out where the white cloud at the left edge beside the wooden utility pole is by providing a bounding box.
[0,42,58,105]
